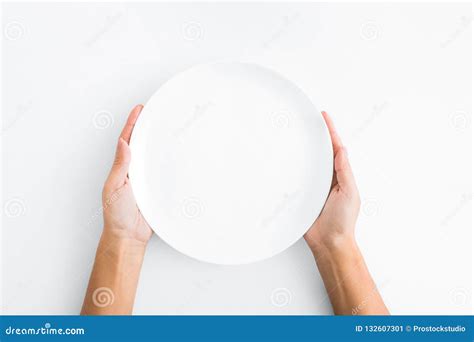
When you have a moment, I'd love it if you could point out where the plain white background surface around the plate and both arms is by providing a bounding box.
[1,3,473,314]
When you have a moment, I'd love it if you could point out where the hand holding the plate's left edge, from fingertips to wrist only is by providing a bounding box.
[102,105,152,245]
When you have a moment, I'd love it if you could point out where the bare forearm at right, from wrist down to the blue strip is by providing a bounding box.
[313,239,389,315]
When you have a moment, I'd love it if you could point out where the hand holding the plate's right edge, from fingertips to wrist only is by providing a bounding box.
[304,112,360,254]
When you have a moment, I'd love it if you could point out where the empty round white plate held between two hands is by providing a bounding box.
[129,63,333,264]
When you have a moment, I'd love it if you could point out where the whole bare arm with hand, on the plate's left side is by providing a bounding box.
[81,106,152,315]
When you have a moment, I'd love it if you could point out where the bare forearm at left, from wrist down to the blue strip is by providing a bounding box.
[81,233,145,315]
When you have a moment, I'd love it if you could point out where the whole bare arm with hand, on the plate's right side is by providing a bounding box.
[305,112,389,315]
